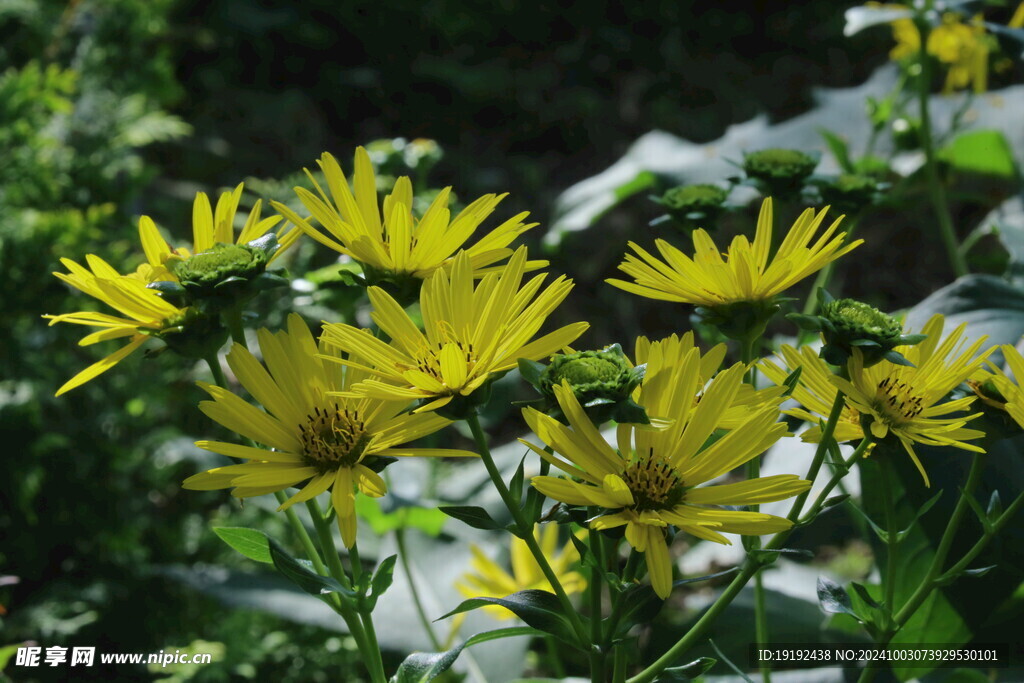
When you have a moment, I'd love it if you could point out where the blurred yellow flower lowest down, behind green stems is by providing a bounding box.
[456,524,587,620]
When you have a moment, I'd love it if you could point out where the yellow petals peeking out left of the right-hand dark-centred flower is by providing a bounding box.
[758,345,864,443]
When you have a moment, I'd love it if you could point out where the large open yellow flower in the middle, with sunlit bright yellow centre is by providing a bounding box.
[323,247,588,412]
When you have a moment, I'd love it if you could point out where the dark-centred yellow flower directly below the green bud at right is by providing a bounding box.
[830,315,993,486]
